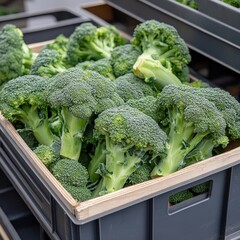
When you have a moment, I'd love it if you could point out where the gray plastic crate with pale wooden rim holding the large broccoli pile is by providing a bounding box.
[0,113,240,240]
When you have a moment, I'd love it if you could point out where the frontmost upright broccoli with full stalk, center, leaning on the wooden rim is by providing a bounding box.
[93,105,166,196]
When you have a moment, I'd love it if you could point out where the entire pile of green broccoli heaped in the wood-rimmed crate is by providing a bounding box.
[0,20,240,202]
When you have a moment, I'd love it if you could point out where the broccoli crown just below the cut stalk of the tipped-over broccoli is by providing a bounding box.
[114,73,156,102]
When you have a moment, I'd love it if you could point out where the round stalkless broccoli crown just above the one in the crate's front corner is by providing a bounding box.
[52,159,89,187]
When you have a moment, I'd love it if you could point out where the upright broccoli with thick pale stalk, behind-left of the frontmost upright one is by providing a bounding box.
[48,67,123,160]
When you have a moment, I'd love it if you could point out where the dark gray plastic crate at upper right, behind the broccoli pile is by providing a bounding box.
[107,0,240,73]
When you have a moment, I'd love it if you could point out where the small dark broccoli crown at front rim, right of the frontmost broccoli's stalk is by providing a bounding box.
[128,162,152,185]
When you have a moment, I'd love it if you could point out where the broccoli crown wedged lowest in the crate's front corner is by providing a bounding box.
[62,183,92,202]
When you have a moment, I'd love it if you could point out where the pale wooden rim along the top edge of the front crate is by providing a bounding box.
[0,113,240,224]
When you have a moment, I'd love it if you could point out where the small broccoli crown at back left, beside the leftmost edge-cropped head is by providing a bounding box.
[30,49,66,77]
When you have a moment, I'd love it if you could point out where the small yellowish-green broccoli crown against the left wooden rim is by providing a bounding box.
[33,145,59,170]
